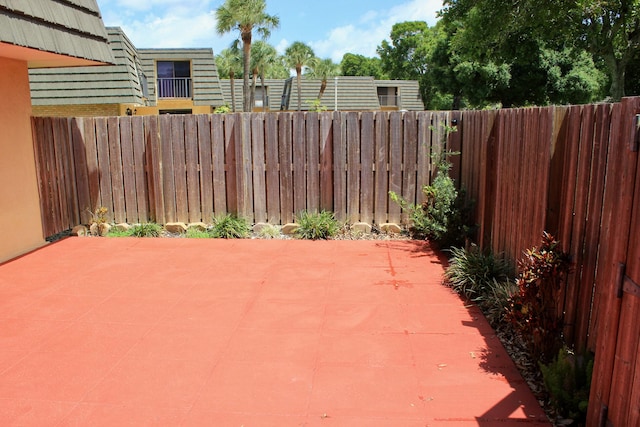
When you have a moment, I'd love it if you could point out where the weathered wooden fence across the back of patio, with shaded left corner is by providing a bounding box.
[32,112,451,236]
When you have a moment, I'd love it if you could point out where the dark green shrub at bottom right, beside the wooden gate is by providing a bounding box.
[540,348,593,423]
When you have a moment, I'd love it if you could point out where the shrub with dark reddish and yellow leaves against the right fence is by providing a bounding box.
[508,232,571,361]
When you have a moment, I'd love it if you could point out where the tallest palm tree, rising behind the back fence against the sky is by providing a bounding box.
[216,0,280,111]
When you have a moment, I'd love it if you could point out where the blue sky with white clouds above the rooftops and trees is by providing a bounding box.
[97,0,442,62]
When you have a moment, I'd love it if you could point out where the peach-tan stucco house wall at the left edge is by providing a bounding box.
[0,57,45,262]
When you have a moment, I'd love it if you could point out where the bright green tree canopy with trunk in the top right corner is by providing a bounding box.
[441,0,640,100]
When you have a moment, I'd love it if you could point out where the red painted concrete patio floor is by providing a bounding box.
[0,238,550,427]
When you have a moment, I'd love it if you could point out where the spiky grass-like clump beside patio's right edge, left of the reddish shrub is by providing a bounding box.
[444,245,511,299]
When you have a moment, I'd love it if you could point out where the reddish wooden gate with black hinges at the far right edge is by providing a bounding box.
[587,98,640,427]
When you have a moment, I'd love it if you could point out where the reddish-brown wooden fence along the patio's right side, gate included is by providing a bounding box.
[458,98,640,427]
